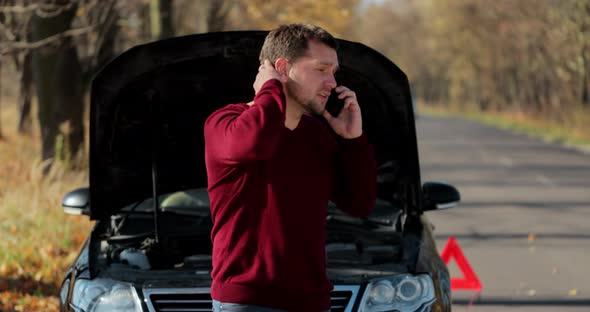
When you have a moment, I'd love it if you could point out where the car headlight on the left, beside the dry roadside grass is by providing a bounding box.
[71,278,141,312]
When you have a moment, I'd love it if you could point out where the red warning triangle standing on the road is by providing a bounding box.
[440,236,482,292]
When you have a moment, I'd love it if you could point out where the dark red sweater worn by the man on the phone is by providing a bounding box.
[205,80,376,312]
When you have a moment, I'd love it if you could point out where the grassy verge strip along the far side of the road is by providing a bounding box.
[418,103,590,152]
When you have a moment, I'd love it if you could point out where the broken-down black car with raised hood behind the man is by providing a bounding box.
[60,31,459,312]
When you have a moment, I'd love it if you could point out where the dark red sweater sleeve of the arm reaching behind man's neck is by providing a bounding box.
[205,79,286,164]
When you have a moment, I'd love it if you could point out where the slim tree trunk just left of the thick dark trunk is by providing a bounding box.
[18,52,33,134]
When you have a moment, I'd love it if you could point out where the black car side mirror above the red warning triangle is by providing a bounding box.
[422,182,461,211]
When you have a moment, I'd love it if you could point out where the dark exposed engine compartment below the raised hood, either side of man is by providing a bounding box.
[99,207,408,270]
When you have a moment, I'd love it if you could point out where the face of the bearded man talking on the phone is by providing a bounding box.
[285,40,338,115]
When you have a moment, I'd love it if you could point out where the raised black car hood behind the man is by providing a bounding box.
[90,31,420,219]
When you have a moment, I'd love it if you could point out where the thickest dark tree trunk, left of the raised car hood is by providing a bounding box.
[32,7,84,166]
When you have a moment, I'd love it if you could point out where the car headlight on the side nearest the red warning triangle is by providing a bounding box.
[360,274,435,312]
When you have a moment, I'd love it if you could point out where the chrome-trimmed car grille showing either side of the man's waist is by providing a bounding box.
[144,286,359,312]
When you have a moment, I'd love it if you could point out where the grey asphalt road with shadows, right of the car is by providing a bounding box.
[417,116,590,312]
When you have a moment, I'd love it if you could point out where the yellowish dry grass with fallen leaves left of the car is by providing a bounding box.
[0,98,92,311]
